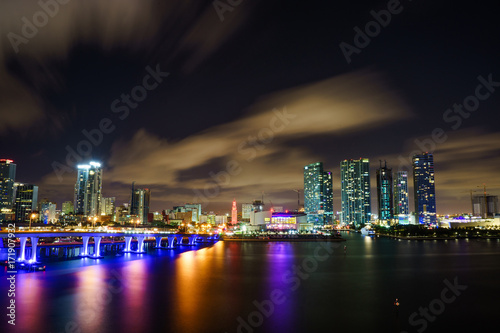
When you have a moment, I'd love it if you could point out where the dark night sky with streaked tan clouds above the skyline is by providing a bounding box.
[0,0,500,214]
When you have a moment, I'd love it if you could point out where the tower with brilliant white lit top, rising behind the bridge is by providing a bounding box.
[74,162,102,216]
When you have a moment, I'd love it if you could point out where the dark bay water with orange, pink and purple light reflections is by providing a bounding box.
[0,233,500,333]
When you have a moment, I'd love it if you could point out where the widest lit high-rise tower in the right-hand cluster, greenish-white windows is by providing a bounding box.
[340,158,371,227]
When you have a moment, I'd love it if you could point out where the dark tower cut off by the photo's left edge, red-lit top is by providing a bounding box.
[0,159,16,221]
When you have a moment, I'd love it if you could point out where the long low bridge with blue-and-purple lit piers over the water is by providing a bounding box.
[0,231,219,263]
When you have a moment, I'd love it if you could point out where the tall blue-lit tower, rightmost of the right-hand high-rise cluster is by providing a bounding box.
[413,153,437,224]
